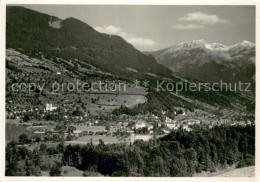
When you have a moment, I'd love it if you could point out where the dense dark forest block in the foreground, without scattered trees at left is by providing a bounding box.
[63,126,255,176]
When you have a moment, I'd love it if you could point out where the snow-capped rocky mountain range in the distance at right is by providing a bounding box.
[146,39,255,83]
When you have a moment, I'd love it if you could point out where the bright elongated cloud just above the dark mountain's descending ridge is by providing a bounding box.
[94,25,155,48]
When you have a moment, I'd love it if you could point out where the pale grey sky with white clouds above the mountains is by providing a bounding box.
[22,5,255,51]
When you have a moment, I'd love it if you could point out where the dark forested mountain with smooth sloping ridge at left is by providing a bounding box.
[6,7,171,76]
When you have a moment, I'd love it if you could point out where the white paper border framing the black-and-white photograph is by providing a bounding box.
[0,0,260,182]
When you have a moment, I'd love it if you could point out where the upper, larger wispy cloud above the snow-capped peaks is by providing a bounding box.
[179,12,227,25]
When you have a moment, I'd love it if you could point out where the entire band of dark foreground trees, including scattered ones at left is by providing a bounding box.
[6,125,255,176]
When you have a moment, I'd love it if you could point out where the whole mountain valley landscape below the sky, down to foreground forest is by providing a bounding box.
[5,6,255,177]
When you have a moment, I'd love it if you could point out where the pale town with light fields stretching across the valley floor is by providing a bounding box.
[6,103,253,145]
